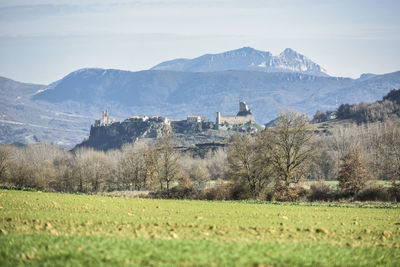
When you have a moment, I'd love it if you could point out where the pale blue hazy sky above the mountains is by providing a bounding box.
[0,0,400,84]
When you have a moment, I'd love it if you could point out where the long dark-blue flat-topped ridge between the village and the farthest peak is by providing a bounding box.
[33,69,400,123]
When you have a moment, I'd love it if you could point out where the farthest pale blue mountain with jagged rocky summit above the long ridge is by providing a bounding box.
[151,47,329,77]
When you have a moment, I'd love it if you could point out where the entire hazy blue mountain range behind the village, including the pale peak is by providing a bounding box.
[0,47,400,147]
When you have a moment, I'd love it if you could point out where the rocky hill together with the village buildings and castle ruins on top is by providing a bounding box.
[77,101,264,153]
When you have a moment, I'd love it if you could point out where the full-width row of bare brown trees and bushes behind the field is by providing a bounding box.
[0,112,400,200]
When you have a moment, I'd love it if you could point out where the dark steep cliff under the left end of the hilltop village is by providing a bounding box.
[77,117,170,150]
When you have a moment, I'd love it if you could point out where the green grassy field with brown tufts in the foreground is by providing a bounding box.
[0,190,400,266]
